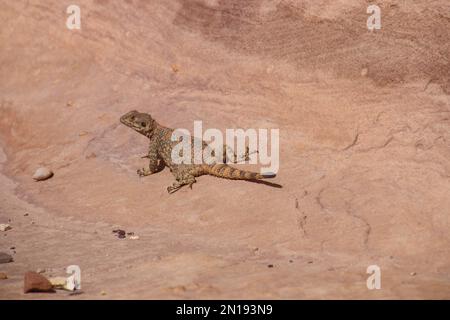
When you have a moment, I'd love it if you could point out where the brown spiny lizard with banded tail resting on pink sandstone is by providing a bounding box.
[120,110,276,194]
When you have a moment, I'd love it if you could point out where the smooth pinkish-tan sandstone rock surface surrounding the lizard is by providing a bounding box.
[0,0,450,299]
